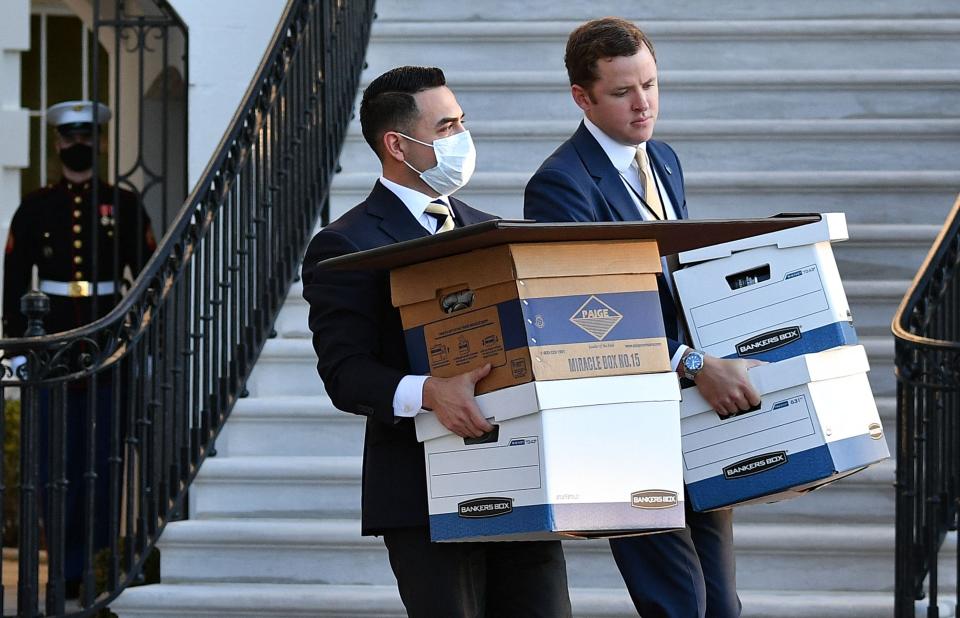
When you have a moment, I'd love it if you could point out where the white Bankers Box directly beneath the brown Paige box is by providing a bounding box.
[416,373,684,541]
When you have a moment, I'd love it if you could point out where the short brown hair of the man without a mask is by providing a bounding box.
[563,17,657,90]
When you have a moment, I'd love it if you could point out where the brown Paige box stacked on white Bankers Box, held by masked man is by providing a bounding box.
[391,241,684,541]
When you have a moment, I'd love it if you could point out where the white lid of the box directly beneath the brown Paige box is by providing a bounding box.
[414,371,680,442]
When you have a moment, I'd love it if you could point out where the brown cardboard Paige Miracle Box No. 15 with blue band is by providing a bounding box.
[390,241,670,394]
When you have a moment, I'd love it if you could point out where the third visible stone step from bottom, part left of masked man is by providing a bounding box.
[190,454,362,519]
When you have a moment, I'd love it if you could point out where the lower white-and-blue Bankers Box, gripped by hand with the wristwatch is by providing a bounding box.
[680,346,890,511]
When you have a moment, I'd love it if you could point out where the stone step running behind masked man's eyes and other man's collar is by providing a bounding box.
[340,117,960,173]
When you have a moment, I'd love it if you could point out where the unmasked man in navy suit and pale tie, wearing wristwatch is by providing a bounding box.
[524,18,759,618]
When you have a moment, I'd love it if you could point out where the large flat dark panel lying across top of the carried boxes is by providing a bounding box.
[317,214,820,270]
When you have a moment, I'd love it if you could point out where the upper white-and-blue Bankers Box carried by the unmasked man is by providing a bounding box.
[673,213,857,361]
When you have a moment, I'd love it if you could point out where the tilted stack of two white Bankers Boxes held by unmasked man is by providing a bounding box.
[674,213,889,511]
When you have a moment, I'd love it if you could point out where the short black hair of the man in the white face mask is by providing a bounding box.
[360,66,447,160]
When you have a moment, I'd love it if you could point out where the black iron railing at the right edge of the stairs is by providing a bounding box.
[893,198,960,618]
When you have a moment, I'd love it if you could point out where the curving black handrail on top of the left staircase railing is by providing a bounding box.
[0,0,296,358]
